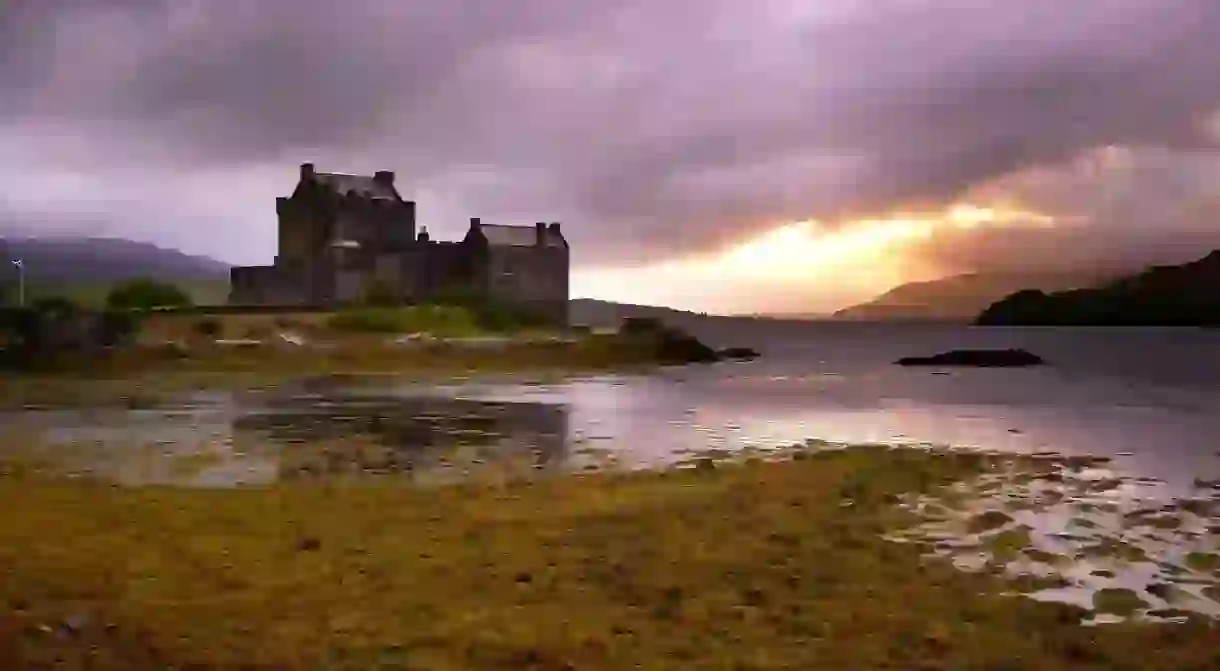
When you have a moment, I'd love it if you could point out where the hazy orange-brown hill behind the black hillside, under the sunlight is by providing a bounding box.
[833,271,1121,321]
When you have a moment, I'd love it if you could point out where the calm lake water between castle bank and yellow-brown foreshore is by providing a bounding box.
[4,322,1220,490]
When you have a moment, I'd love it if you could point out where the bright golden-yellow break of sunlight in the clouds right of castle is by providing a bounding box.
[573,204,1055,312]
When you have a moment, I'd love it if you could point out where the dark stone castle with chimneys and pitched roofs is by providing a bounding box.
[229,163,569,323]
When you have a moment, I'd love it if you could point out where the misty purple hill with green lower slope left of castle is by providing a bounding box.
[0,237,229,303]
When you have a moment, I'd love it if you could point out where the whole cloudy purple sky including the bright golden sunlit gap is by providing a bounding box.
[0,0,1220,312]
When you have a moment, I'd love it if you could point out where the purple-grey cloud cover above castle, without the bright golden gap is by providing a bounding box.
[0,0,1220,275]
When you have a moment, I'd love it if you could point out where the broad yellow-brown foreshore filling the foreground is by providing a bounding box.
[0,448,1220,670]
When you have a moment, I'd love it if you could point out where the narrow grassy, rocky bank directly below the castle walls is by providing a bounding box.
[0,306,692,403]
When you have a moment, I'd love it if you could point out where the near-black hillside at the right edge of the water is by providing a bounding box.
[976,249,1220,326]
